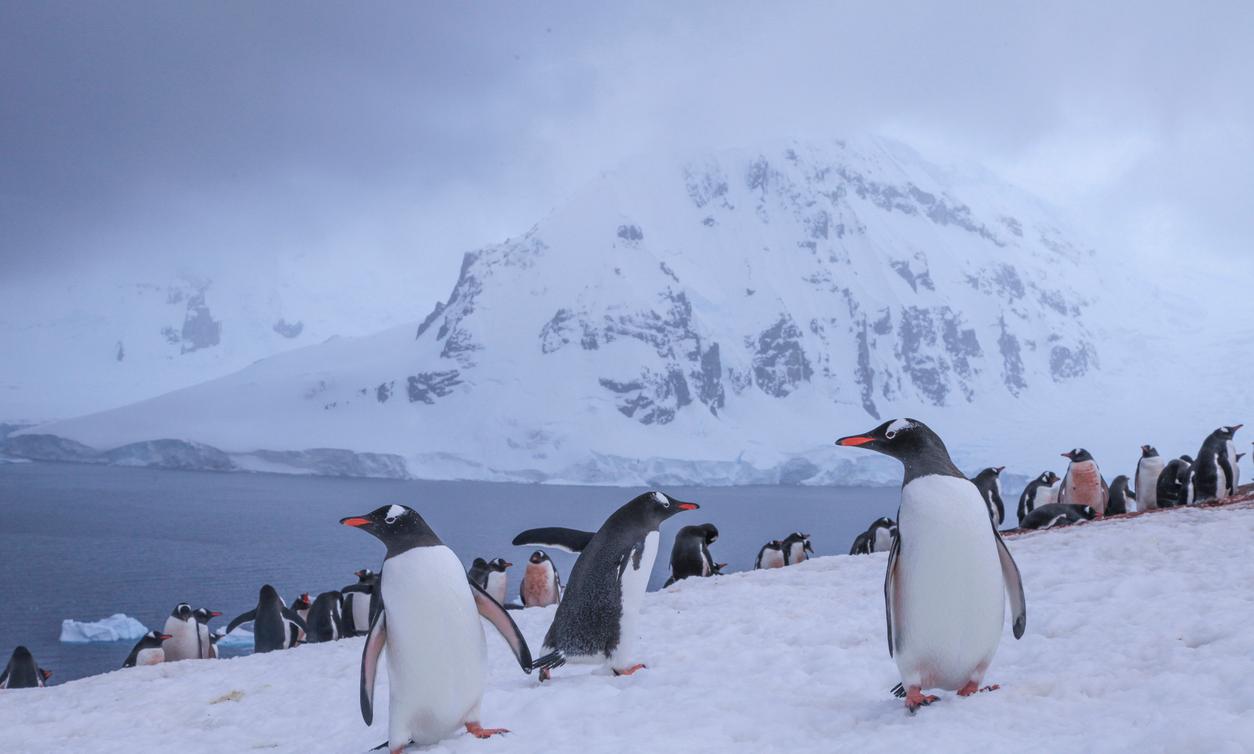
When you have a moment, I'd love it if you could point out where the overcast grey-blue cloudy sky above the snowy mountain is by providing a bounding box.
[0,0,1254,298]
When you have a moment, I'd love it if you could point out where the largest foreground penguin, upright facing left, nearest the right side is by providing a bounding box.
[836,419,1027,711]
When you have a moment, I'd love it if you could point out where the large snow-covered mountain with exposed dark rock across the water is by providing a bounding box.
[10,139,1229,483]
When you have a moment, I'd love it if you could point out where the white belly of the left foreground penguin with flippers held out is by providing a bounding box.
[382,544,487,748]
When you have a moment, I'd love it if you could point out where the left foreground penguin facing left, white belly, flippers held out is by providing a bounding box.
[340,506,532,753]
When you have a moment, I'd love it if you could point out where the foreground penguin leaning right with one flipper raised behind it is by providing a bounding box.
[514,492,700,680]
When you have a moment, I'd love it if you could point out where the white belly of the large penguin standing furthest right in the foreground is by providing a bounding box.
[893,475,1006,690]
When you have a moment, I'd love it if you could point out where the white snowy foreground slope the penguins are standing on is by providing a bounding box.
[0,503,1254,754]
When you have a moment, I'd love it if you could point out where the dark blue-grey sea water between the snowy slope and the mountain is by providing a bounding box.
[0,463,899,682]
